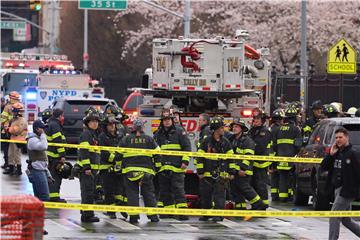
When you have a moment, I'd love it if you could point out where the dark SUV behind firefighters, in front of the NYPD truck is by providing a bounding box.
[51,97,117,156]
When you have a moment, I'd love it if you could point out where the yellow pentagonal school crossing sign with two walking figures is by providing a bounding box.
[327,38,356,74]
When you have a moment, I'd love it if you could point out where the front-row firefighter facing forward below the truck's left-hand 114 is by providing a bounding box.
[154,109,191,220]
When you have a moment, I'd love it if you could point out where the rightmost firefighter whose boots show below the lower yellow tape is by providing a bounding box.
[196,117,236,222]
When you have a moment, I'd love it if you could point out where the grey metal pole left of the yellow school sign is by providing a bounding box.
[300,0,308,111]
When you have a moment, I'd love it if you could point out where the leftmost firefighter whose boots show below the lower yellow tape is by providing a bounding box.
[77,111,100,222]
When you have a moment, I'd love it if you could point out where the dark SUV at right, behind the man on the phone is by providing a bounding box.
[294,117,360,210]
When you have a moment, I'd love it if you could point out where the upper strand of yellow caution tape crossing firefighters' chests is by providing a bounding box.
[0,139,322,163]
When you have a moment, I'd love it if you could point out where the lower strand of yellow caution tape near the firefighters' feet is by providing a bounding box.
[44,202,360,218]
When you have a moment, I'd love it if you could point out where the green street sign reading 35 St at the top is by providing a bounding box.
[79,0,127,10]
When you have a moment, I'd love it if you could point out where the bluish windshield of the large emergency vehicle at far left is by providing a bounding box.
[3,73,37,95]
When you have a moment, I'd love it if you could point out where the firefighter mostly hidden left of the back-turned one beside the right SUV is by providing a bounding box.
[269,109,285,201]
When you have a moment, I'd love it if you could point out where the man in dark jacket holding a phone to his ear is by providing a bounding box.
[320,128,360,240]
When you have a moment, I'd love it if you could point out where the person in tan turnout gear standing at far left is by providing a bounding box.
[4,102,27,176]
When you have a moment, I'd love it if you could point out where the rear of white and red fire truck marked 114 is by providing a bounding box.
[131,31,271,150]
